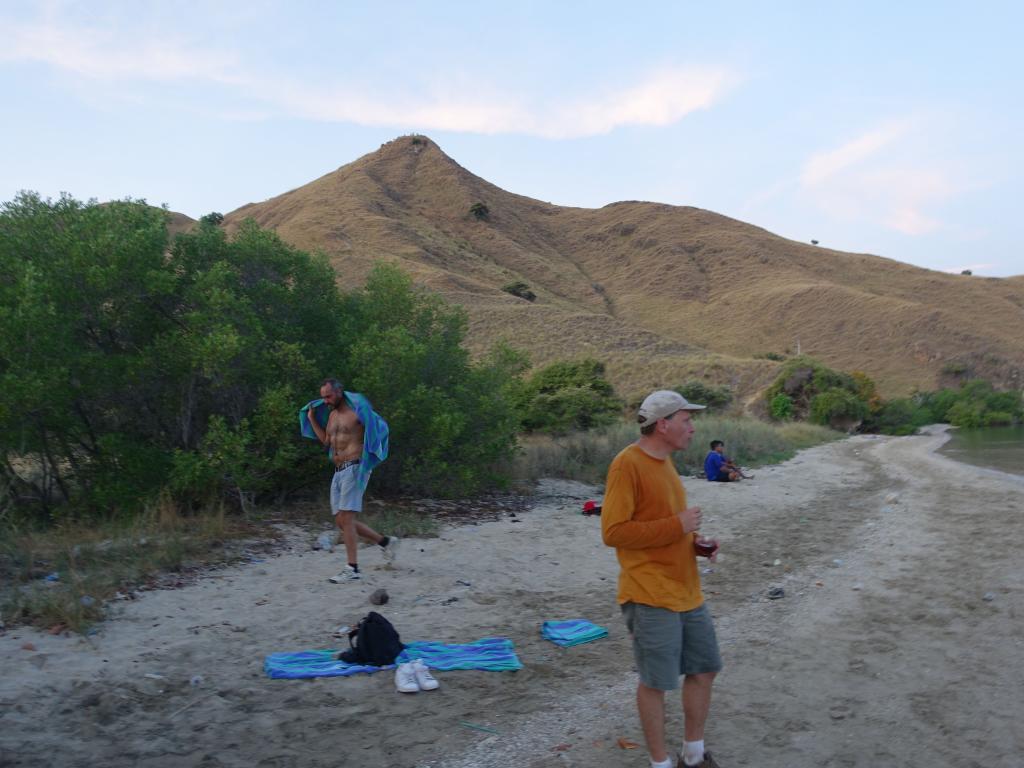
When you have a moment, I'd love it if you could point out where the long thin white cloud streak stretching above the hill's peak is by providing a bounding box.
[0,19,737,138]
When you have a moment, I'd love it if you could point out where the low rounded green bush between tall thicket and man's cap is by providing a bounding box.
[512,358,623,432]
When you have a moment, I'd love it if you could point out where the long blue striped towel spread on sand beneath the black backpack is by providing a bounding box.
[263,637,522,680]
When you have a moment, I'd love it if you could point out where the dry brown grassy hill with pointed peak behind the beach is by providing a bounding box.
[225,136,1024,403]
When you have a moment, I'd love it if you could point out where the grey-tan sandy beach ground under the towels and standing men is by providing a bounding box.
[0,428,1024,768]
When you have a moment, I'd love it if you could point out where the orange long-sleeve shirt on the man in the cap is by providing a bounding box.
[601,445,703,611]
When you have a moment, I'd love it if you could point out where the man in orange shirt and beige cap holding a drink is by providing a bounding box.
[601,390,722,768]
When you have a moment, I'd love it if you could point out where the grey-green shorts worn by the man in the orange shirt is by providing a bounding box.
[622,603,722,690]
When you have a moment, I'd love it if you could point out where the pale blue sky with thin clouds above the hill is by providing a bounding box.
[0,0,1024,276]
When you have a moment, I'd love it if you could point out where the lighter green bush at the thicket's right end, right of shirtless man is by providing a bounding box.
[335,265,526,495]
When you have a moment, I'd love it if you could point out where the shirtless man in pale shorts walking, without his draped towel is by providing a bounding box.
[306,379,398,584]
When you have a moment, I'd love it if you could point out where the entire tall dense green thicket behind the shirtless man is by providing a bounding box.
[0,195,525,521]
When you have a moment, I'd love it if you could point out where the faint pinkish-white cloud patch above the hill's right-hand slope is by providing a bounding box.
[800,120,961,236]
